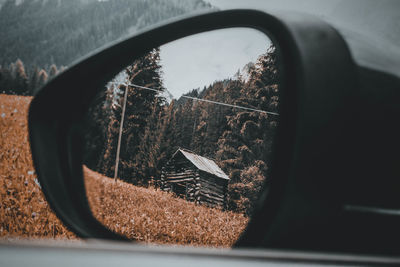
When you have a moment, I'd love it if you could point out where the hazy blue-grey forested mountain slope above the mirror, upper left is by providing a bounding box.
[0,0,211,69]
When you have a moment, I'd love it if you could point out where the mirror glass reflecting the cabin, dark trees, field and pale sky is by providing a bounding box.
[83,28,280,247]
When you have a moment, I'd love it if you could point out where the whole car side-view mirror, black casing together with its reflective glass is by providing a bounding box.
[29,10,400,255]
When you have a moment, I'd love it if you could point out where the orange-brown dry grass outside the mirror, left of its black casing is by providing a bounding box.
[0,94,75,241]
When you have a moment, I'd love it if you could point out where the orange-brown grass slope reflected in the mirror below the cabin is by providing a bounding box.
[84,168,247,247]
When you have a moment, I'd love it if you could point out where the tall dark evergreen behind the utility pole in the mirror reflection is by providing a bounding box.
[90,49,165,184]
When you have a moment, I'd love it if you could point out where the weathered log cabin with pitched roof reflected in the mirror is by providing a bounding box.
[160,148,229,208]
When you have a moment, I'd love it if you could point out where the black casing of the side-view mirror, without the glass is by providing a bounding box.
[29,10,388,254]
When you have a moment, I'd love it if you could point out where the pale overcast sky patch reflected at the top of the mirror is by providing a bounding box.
[160,28,271,98]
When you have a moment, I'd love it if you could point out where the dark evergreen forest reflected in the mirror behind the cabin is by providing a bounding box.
[85,47,279,218]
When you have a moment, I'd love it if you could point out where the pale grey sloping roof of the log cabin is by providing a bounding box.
[174,148,229,180]
